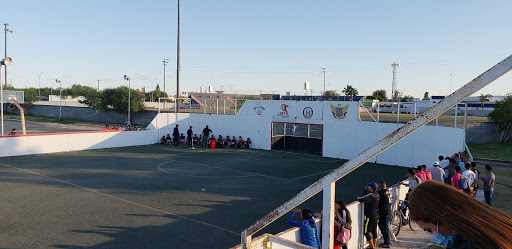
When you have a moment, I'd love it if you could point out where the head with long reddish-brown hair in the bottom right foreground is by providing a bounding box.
[409,181,512,249]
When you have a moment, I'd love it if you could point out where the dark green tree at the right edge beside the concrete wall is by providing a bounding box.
[488,93,512,143]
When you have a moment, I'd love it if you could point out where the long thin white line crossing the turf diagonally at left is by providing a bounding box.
[0,163,240,236]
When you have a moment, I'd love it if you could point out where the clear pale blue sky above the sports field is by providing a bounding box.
[0,0,512,98]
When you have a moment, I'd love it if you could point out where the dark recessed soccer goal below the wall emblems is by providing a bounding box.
[272,122,324,154]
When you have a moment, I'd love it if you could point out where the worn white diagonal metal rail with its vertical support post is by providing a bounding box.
[241,55,512,249]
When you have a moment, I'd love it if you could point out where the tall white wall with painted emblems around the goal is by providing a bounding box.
[148,101,464,167]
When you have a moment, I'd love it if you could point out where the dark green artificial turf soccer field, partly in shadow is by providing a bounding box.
[0,145,405,248]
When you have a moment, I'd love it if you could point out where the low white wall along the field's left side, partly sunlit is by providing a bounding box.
[0,130,158,157]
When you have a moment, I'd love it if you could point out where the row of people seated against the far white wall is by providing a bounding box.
[160,133,252,149]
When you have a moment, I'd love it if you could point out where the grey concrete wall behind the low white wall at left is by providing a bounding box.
[7,105,158,127]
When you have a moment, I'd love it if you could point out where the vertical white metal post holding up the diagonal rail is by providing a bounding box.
[322,181,336,249]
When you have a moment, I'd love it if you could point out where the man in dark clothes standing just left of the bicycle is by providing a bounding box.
[377,181,391,248]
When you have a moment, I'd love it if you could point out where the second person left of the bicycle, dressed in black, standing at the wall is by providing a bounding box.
[357,182,379,249]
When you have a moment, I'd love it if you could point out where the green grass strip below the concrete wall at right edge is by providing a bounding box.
[468,141,512,162]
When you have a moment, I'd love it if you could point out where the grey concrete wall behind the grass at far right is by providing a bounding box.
[466,123,512,144]
